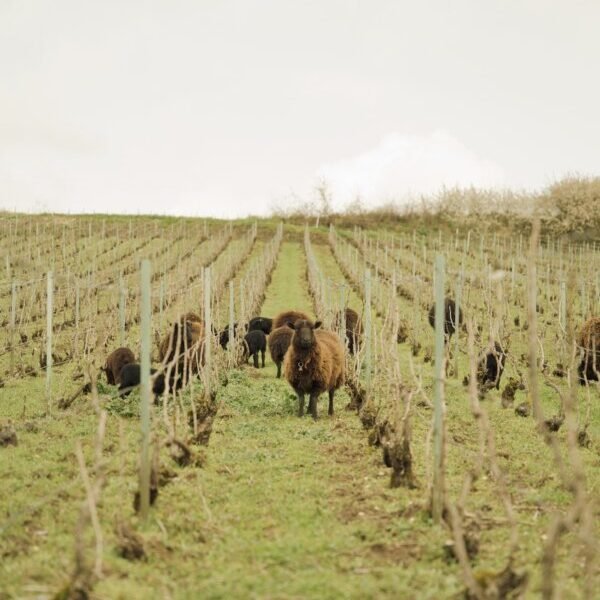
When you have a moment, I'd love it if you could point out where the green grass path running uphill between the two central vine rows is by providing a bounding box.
[99,243,459,598]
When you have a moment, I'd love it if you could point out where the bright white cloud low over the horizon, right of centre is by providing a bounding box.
[317,131,504,206]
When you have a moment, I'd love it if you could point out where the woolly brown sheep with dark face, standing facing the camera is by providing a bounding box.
[283,319,345,420]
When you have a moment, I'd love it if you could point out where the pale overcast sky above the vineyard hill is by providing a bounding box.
[0,0,600,217]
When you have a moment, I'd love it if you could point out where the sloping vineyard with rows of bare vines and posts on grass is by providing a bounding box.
[0,215,600,599]
